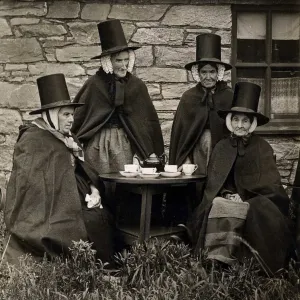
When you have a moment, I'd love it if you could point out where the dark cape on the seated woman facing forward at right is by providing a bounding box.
[189,135,292,272]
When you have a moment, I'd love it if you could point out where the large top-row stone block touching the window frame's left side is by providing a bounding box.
[161,5,231,29]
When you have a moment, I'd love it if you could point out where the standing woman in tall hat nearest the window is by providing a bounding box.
[167,33,233,222]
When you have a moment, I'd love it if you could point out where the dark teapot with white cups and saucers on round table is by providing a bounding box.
[120,155,198,179]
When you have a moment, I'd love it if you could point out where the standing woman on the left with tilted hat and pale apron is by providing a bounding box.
[73,20,164,221]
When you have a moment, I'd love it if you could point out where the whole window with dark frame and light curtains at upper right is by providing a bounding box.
[232,5,300,134]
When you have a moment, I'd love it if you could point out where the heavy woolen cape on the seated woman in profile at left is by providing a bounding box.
[4,125,105,263]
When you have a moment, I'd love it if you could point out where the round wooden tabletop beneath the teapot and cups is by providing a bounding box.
[99,173,206,185]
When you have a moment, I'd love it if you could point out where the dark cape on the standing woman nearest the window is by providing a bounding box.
[170,81,233,165]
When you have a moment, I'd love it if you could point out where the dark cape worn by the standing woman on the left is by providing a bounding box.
[72,69,164,159]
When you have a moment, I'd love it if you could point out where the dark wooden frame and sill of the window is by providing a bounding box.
[231,5,300,135]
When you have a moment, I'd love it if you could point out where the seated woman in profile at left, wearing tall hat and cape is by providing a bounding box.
[4,74,113,264]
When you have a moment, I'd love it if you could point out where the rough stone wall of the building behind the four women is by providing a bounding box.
[0,0,299,190]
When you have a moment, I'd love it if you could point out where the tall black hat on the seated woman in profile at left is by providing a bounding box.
[29,74,83,115]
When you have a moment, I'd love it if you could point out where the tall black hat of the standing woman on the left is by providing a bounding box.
[92,19,140,59]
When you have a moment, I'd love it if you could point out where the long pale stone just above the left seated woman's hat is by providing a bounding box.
[28,62,85,77]
